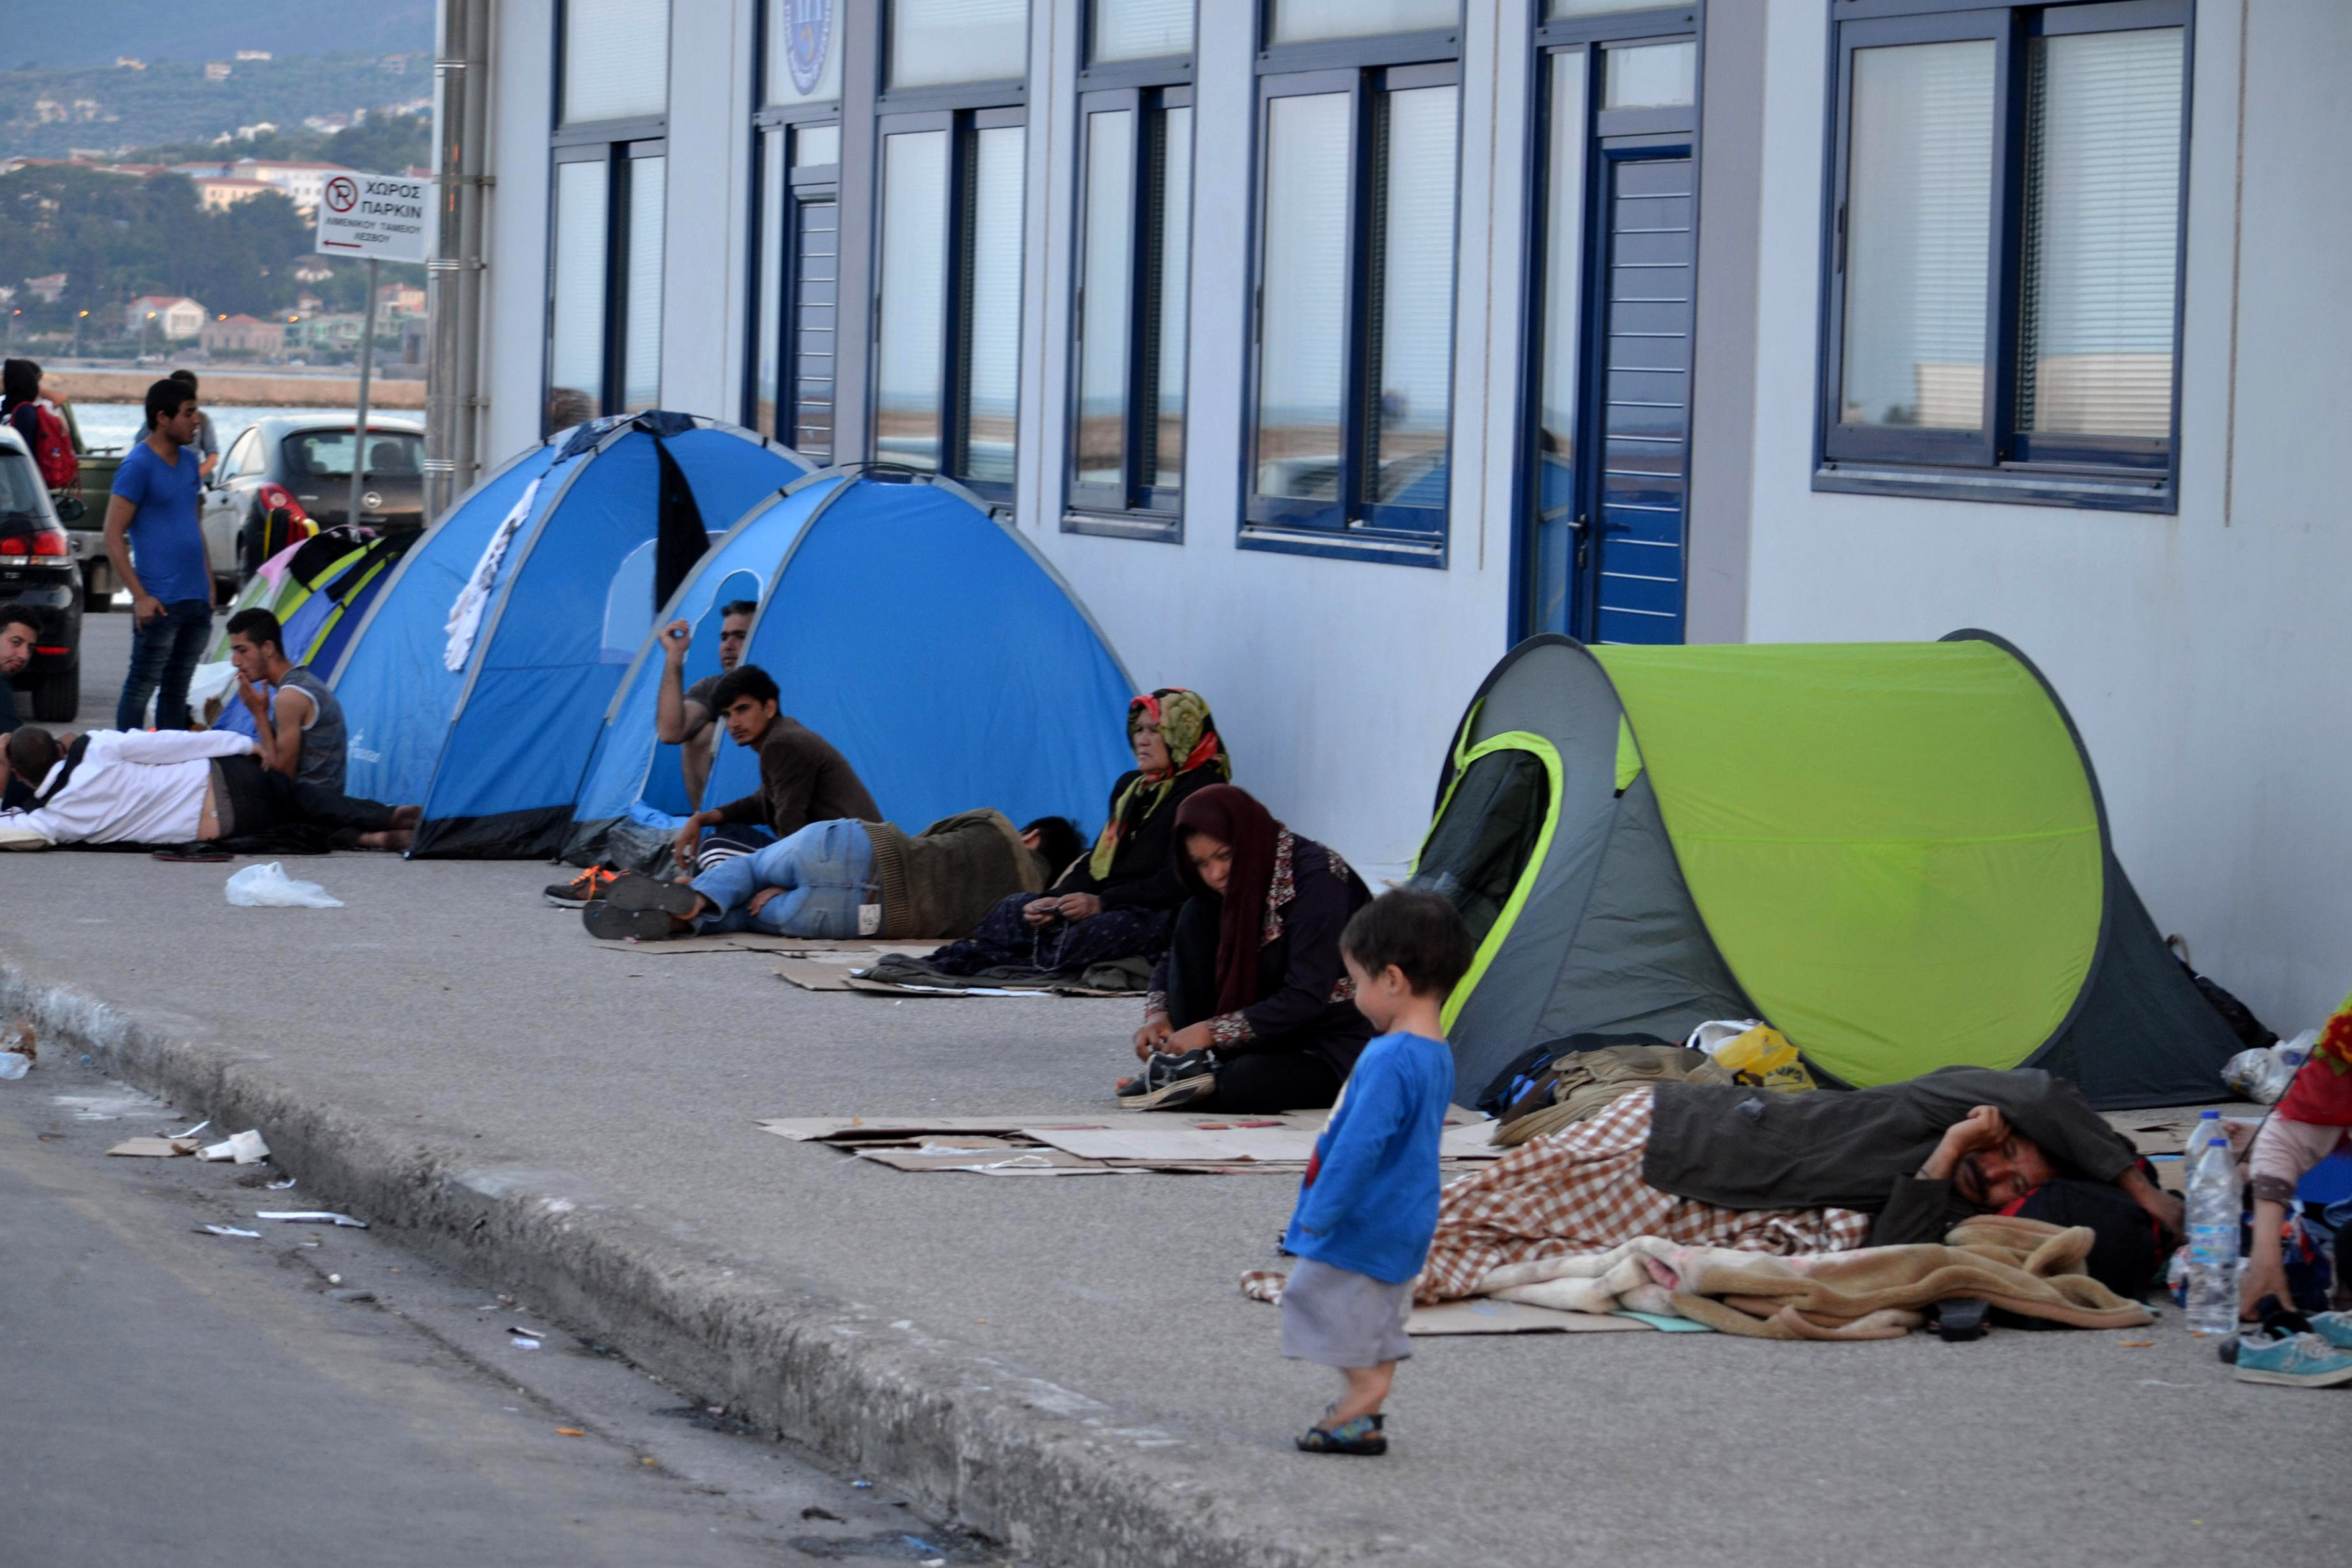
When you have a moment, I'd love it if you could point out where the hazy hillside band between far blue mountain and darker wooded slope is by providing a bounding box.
[0,51,433,157]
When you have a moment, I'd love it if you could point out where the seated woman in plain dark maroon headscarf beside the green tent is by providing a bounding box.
[1119,785,1372,1115]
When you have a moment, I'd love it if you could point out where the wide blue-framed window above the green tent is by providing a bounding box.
[1816,0,2187,512]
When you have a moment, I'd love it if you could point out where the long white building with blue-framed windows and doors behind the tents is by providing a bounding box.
[444,0,2352,1028]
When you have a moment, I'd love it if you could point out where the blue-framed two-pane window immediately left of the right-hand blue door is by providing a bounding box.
[1242,58,1460,566]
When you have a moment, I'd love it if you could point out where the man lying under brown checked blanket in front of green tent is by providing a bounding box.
[1421,1067,2180,1300]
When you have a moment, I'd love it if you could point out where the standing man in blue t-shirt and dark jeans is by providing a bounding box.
[106,381,212,729]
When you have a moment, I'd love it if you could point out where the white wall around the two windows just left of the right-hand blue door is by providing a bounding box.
[1018,0,1529,877]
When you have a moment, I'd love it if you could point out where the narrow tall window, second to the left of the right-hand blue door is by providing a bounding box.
[1063,0,1192,540]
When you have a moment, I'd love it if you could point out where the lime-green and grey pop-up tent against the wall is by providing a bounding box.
[1413,633,2239,1107]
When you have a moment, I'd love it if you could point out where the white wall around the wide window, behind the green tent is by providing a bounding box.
[1747,0,2352,1032]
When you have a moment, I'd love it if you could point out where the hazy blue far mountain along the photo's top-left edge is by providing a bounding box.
[0,0,435,72]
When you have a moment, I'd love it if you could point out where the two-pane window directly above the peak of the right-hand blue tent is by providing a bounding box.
[872,108,1028,501]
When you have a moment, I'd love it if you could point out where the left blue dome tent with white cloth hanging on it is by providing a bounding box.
[337,412,807,858]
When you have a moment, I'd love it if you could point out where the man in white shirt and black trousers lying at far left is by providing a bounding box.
[0,724,424,848]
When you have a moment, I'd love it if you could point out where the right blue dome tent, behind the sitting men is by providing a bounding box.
[567,470,1136,863]
